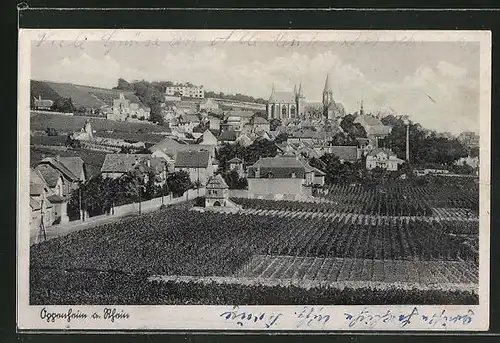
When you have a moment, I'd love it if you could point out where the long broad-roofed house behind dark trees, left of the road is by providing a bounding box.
[101,154,173,186]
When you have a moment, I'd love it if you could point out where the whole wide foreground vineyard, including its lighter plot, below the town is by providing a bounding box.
[30,203,478,303]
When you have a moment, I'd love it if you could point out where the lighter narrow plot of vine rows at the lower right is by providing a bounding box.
[235,255,478,285]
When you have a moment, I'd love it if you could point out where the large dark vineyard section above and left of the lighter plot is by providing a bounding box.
[30,209,478,276]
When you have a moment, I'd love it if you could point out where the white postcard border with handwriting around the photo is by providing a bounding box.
[17,29,491,331]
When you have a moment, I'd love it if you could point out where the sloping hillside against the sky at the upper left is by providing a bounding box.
[30,80,146,108]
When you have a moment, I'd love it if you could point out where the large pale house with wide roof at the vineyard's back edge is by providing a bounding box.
[247,154,324,200]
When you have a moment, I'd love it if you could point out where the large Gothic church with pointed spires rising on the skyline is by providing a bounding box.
[267,74,345,121]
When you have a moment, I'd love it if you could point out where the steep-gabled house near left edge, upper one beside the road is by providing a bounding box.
[35,156,86,198]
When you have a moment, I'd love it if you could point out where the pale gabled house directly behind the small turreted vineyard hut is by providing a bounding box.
[175,150,214,185]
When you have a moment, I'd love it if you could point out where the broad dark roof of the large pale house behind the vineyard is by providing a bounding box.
[248,155,306,179]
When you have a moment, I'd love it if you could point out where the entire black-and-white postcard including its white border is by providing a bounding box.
[18,30,491,331]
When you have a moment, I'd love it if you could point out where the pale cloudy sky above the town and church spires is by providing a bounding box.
[31,42,479,133]
